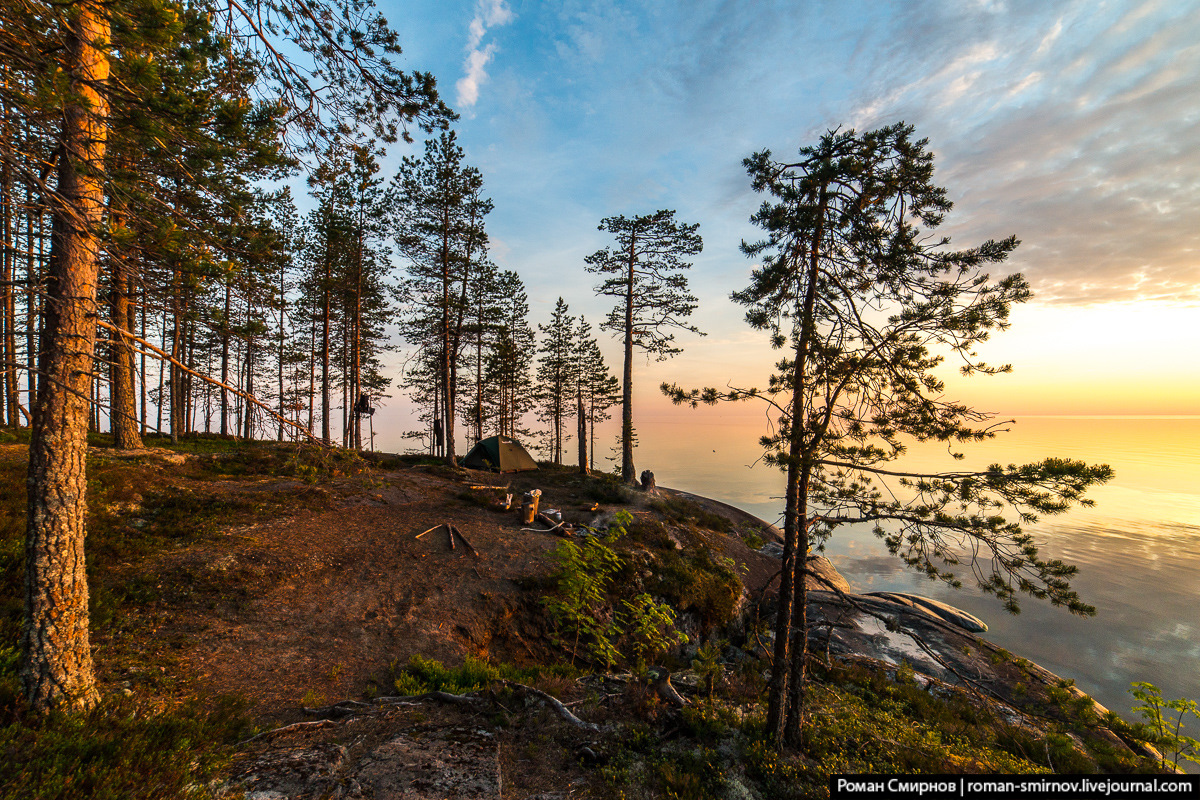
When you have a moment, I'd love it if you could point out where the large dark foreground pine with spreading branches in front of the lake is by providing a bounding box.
[664,124,1111,742]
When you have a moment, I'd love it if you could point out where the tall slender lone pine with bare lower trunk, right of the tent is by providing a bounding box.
[586,211,703,483]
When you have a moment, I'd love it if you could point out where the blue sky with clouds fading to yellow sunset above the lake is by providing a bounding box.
[362,0,1200,443]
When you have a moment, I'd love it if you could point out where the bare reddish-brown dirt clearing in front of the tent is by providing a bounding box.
[82,450,778,722]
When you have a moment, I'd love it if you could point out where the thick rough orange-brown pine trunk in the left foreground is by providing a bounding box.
[20,0,109,714]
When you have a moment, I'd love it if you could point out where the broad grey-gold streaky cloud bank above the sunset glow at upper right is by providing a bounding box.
[850,2,1200,305]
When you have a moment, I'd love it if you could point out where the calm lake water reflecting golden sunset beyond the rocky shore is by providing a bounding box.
[636,419,1200,735]
